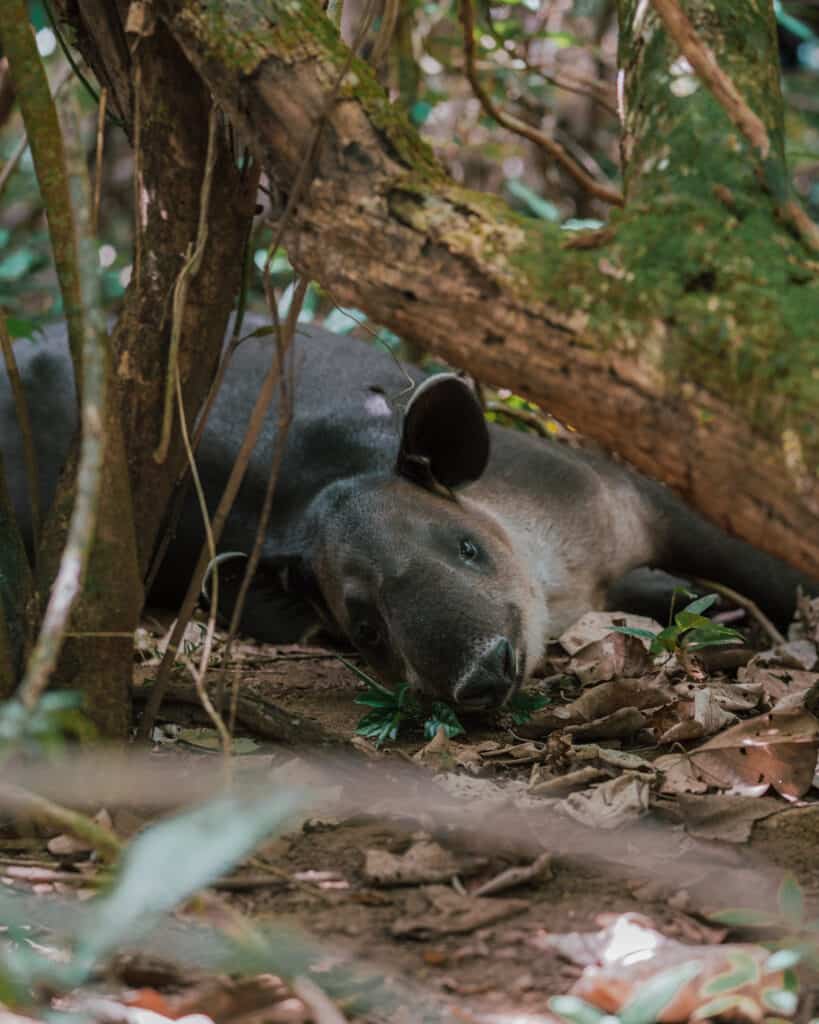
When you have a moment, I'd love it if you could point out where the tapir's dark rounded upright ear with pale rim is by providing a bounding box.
[396,374,489,490]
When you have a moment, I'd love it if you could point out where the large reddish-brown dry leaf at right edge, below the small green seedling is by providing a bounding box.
[688,709,819,800]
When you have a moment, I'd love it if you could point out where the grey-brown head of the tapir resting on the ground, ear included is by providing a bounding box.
[303,375,543,708]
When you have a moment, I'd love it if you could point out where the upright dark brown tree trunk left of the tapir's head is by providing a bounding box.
[36,0,258,736]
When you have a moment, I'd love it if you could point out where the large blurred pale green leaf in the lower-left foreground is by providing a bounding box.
[75,790,302,977]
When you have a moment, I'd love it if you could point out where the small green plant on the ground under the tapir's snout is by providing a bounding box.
[339,657,548,746]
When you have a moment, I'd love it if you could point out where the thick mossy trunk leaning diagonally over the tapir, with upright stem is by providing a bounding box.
[150,0,819,577]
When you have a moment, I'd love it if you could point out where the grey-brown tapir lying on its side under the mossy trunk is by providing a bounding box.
[0,315,817,709]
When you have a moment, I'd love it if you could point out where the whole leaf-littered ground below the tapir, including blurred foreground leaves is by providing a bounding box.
[0,589,819,1024]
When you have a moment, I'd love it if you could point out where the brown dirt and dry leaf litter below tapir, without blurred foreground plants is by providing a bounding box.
[0,602,819,1024]
